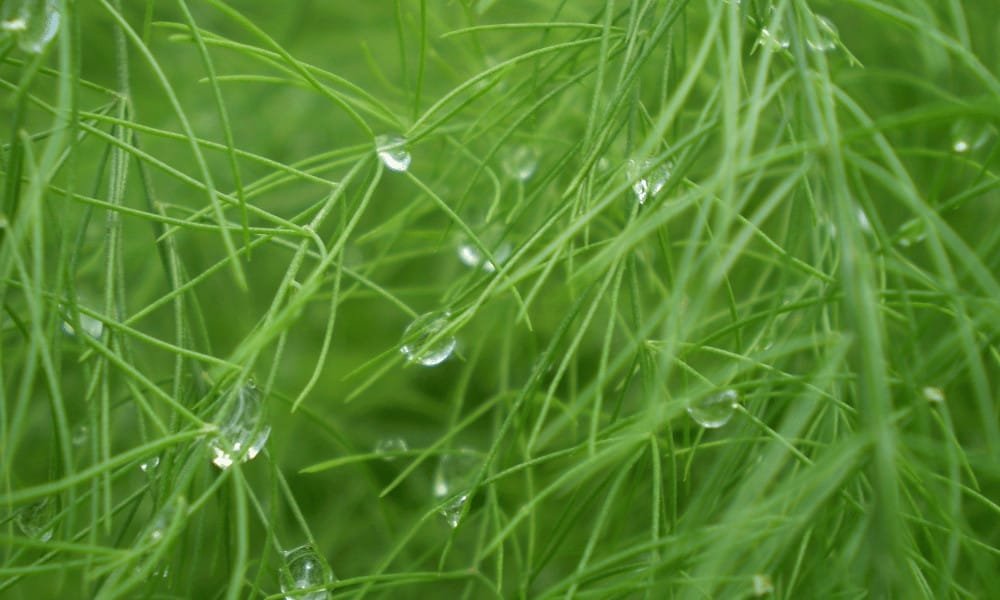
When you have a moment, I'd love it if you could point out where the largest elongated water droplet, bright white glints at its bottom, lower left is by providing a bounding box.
[209,380,271,469]
